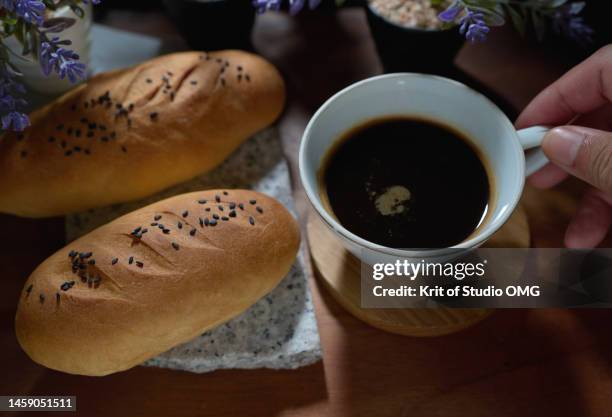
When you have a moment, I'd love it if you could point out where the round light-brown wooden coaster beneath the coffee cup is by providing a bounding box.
[306,205,530,336]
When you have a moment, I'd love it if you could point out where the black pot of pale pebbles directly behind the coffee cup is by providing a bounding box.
[365,4,465,74]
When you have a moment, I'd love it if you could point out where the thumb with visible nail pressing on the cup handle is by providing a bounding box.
[542,126,612,195]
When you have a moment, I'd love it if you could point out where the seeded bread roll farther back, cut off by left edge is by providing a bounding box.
[0,51,285,217]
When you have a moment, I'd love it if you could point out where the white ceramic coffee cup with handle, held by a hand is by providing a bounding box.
[299,73,549,265]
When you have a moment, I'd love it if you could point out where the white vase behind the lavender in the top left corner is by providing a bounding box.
[5,4,92,95]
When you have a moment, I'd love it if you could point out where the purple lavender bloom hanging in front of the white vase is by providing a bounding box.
[39,38,86,83]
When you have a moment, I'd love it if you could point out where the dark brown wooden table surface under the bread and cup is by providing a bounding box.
[0,10,612,417]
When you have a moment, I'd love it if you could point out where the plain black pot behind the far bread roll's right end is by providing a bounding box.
[163,0,255,51]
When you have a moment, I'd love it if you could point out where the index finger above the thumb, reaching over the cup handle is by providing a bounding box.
[516,45,612,128]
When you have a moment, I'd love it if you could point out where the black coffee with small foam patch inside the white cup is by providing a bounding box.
[320,117,491,249]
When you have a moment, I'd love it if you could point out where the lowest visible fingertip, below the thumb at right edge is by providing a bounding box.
[565,189,612,249]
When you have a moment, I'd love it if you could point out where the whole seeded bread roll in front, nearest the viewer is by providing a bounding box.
[15,190,300,375]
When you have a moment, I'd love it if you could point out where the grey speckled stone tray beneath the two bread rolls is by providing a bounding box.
[66,129,321,372]
